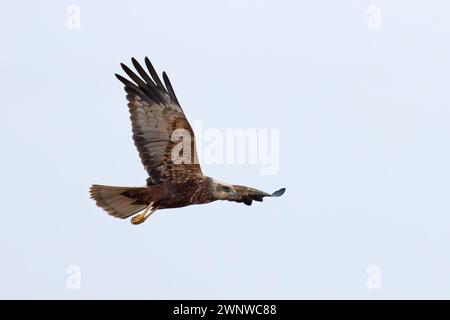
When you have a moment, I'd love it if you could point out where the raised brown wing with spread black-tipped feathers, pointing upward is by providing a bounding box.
[116,57,203,185]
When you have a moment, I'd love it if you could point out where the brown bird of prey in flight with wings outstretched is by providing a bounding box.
[90,57,285,224]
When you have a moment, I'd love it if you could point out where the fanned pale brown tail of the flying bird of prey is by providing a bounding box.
[90,184,148,219]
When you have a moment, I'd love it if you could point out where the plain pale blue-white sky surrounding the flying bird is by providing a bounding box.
[0,0,450,299]
